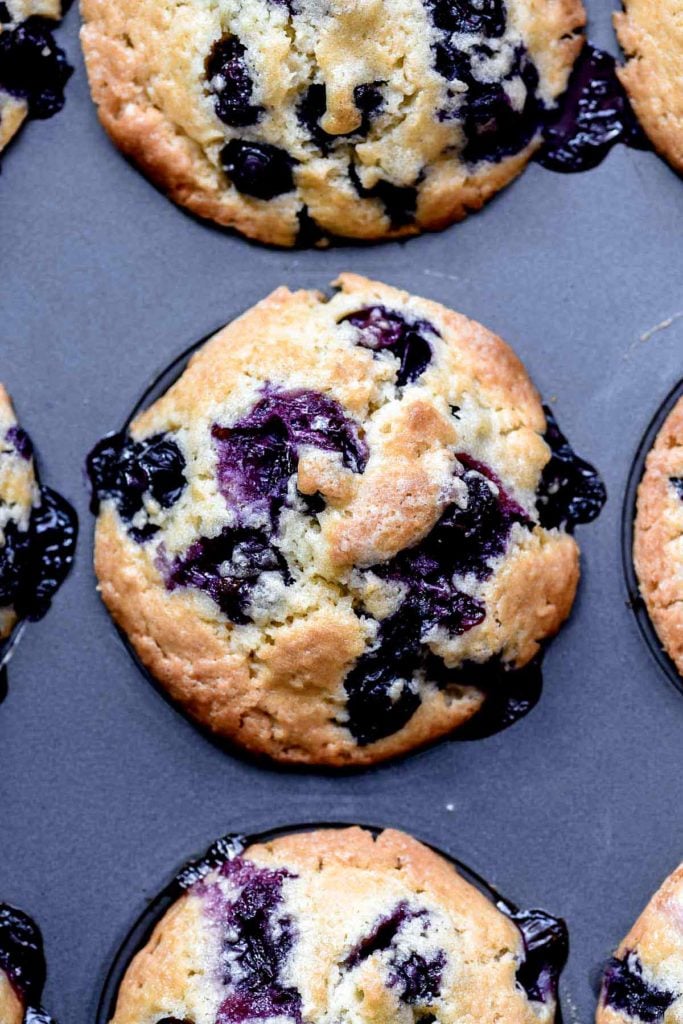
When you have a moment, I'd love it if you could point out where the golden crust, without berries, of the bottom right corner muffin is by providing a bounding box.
[595,864,683,1024]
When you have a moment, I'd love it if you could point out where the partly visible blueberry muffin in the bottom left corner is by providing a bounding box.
[0,903,54,1024]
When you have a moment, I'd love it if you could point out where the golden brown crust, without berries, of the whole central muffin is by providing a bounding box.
[95,274,579,765]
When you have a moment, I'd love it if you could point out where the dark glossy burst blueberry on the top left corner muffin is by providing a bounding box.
[0,15,74,120]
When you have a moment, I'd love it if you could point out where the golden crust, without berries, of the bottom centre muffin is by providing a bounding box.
[113,828,555,1024]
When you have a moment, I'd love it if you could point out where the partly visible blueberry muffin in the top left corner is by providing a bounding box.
[0,0,73,151]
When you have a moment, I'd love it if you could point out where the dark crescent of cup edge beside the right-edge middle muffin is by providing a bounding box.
[622,380,683,693]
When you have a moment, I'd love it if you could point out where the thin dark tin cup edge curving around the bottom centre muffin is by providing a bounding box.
[94,821,568,1024]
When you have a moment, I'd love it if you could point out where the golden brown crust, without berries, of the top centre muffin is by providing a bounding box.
[81,0,585,246]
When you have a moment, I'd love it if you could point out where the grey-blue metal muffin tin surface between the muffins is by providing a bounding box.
[0,0,683,1024]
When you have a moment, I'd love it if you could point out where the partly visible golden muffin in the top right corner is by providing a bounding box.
[614,0,683,173]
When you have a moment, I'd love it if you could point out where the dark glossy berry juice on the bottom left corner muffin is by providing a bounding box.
[0,903,57,1024]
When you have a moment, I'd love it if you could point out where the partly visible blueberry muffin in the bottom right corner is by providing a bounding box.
[596,864,683,1024]
